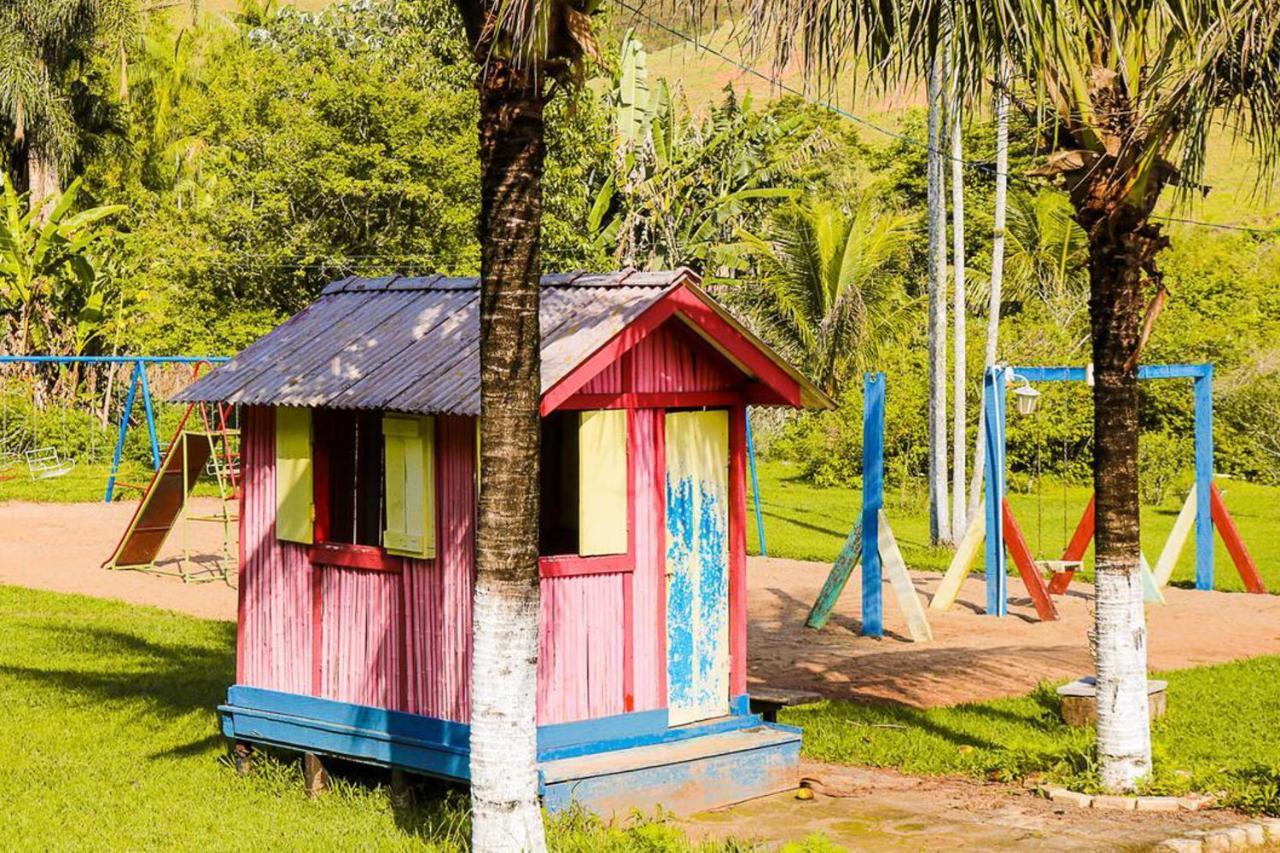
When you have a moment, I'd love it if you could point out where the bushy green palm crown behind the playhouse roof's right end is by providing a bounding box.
[728,192,914,394]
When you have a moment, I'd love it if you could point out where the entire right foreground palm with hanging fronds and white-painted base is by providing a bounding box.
[751,0,1280,789]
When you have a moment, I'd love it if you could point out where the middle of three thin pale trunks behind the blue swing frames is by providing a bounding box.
[951,86,969,538]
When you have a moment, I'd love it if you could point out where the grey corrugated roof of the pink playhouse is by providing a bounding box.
[174,269,696,415]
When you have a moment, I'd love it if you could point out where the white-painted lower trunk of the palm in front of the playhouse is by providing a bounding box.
[471,575,547,853]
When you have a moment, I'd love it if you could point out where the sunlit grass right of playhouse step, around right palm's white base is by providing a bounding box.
[780,657,1280,815]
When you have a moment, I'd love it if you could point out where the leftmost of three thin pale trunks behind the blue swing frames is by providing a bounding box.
[928,59,951,544]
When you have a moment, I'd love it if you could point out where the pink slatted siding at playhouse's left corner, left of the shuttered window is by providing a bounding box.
[237,406,314,693]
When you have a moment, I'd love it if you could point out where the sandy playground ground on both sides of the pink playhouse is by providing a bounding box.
[0,498,1280,706]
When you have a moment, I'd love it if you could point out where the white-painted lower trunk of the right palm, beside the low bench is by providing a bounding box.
[1091,564,1151,790]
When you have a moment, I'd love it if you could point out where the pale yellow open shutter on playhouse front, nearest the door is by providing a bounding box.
[577,409,627,557]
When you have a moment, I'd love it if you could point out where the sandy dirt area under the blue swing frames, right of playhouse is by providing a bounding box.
[748,550,1280,707]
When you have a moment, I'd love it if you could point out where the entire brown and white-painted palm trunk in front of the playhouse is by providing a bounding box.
[471,59,547,853]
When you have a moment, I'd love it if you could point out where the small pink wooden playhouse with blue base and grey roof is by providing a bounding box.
[178,270,829,812]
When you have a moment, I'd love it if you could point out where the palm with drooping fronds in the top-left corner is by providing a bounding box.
[0,0,138,216]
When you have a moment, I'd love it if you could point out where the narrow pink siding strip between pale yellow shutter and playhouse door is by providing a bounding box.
[631,409,667,711]
